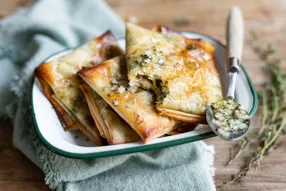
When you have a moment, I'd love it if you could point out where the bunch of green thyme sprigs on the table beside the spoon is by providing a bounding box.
[220,31,286,189]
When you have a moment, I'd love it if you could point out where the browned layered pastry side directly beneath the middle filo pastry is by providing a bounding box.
[80,84,141,145]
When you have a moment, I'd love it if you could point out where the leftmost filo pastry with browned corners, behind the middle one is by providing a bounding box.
[35,32,122,145]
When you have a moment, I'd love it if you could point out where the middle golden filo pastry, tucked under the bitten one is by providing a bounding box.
[78,56,178,143]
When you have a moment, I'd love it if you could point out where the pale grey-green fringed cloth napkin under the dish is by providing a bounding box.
[0,0,215,191]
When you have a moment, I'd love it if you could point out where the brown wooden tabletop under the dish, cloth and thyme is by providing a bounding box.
[0,0,286,191]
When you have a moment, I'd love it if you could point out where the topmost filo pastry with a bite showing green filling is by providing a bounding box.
[126,23,223,123]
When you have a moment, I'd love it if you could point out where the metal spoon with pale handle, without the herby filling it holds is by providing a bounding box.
[206,7,250,140]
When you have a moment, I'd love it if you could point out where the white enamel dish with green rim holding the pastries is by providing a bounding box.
[31,32,258,158]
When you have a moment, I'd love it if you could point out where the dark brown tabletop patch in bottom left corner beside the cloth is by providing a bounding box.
[0,120,48,191]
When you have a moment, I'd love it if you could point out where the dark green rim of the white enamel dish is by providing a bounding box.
[30,32,258,159]
